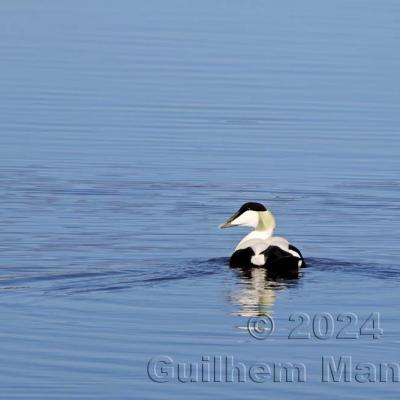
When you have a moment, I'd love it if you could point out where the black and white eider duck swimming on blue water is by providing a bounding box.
[219,202,305,273]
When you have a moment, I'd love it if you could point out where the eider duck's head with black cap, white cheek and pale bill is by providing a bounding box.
[219,202,276,231]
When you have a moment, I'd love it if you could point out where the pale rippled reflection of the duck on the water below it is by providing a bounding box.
[229,268,300,317]
